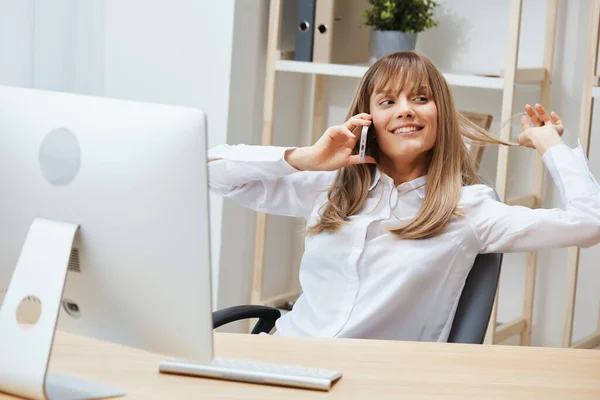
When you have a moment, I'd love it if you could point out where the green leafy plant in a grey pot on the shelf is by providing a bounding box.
[363,0,439,58]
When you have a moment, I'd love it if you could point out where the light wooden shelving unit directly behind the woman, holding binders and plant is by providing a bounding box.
[251,0,558,345]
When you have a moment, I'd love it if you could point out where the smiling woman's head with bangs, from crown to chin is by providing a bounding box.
[346,51,458,181]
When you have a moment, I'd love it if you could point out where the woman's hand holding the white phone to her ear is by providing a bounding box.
[285,113,376,171]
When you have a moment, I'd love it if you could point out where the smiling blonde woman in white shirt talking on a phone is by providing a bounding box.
[209,52,600,341]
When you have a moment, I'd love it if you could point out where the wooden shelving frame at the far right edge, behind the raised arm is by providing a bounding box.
[562,0,600,348]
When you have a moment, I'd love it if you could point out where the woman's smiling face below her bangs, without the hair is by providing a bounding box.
[370,87,438,164]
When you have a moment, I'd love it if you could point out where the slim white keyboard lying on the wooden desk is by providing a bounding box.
[159,359,342,391]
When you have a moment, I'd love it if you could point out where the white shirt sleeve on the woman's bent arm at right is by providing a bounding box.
[467,144,600,253]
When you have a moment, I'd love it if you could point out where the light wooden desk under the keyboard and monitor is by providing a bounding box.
[0,332,600,400]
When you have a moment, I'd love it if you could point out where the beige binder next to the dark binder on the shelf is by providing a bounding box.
[313,0,372,64]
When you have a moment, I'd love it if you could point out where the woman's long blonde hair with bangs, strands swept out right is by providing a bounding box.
[308,51,515,239]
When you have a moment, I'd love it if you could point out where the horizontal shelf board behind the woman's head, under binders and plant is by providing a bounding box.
[275,60,546,90]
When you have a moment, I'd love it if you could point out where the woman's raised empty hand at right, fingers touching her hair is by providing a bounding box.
[517,104,565,155]
